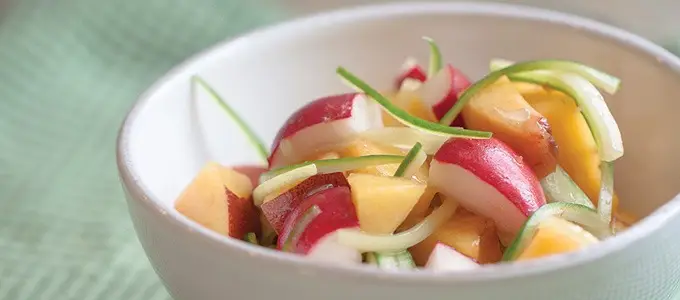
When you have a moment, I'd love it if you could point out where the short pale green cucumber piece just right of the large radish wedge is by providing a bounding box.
[541,166,595,209]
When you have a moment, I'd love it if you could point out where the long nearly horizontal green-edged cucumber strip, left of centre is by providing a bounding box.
[260,155,404,182]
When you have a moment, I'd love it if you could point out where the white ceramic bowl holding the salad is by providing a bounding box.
[118,3,680,300]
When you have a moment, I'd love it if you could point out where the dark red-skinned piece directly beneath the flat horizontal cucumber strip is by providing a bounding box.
[260,172,349,234]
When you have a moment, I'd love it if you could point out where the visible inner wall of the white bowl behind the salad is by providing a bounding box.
[123,2,680,227]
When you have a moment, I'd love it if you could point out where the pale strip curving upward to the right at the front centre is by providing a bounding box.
[338,199,458,252]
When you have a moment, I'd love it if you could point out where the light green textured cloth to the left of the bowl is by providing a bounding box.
[0,0,284,300]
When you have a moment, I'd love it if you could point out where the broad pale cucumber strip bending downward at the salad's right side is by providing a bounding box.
[491,60,623,162]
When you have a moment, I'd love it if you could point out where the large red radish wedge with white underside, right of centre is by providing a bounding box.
[430,138,545,234]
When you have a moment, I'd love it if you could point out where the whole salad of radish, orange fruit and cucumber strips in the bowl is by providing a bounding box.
[175,38,633,271]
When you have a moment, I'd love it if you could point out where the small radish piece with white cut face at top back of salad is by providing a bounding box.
[419,64,471,127]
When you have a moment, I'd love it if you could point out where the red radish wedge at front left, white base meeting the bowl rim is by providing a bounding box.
[277,187,361,263]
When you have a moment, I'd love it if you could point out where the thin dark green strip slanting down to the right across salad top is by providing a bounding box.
[336,67,491,139]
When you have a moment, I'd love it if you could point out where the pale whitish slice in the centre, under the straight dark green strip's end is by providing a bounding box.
[359,127,449,155]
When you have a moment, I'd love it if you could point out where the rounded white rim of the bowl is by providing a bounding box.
[116,2,680,285]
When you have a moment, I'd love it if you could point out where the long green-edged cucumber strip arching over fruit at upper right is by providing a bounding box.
[439,60,620,124]
